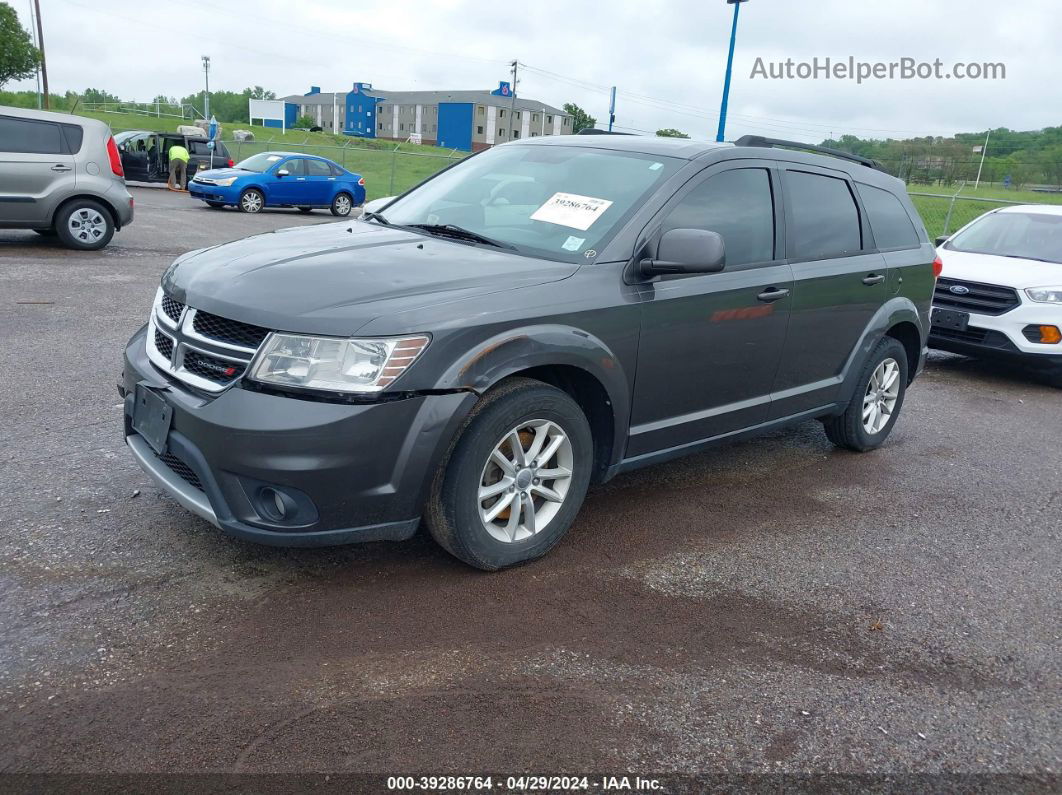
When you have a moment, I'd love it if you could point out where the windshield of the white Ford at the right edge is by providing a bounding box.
[944,212,1062,262]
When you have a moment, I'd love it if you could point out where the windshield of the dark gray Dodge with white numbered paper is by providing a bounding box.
[383,145,683,261]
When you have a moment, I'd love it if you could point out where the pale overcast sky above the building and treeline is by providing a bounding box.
[6,0,1062,141]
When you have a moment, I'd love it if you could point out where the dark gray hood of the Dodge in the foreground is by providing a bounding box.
[162,221,579,335]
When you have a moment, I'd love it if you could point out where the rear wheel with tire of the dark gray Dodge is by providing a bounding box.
[822,336,908,452]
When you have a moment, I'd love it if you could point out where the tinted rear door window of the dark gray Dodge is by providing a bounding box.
[786,171,862,260]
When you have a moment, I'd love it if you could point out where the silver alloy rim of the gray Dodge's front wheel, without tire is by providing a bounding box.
[477,419,575,543]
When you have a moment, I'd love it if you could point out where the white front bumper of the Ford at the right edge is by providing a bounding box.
[929,301,1062,370]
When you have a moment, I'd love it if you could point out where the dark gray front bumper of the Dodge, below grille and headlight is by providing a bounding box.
[120,329,477,546]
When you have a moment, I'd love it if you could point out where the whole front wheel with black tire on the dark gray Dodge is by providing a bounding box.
[425,378,594,571]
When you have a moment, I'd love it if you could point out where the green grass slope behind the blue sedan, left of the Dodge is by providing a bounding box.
[69,107,467,200]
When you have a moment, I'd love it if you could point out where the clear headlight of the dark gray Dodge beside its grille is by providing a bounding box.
[251,333,430,392]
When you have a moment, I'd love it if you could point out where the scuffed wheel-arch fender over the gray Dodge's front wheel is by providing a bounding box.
[436,325,631,464]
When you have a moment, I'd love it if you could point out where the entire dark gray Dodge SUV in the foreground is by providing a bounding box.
[120,136,936,569]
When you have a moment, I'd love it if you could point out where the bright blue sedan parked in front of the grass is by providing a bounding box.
[188,152,365,215]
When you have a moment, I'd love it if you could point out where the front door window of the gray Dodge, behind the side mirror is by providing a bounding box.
[664,169,774,265]
